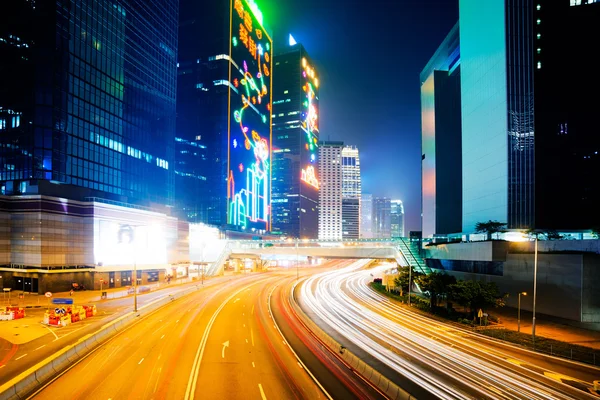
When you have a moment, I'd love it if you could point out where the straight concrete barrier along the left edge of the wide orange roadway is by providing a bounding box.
[0,285,202,400]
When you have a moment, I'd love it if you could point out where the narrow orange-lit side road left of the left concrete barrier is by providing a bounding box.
[0,276,238,385]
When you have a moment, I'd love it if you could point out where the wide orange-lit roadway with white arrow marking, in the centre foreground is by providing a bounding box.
[27,260,381,400]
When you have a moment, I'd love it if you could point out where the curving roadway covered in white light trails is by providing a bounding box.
[299,260,600,399]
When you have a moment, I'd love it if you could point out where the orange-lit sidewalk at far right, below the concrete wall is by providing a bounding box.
[491,307,600,349]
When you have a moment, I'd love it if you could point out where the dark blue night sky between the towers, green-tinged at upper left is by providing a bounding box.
[264,0,458,231]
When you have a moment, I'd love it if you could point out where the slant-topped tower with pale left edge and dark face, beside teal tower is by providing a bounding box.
[421,23,462,238]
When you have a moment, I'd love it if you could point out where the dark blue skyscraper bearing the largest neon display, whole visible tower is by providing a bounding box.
[176,0,272,233]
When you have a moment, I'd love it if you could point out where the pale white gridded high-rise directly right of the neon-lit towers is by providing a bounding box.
[318,141,344,240]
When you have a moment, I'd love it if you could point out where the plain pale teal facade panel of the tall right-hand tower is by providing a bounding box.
[459,0,509,232]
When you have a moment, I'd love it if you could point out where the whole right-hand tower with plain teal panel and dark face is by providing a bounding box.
[459,0,600,232]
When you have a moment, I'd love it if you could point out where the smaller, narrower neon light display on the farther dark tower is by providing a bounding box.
[300,57,319,189]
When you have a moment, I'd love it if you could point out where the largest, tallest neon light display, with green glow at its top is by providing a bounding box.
[227,0,273,231]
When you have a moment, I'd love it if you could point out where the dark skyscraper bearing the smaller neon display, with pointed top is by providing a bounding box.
[272,38,320,239]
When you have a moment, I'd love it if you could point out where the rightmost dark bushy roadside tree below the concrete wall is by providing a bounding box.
[450,280,507,313]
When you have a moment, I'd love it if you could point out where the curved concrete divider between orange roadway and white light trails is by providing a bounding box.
[290,284,416,400]
